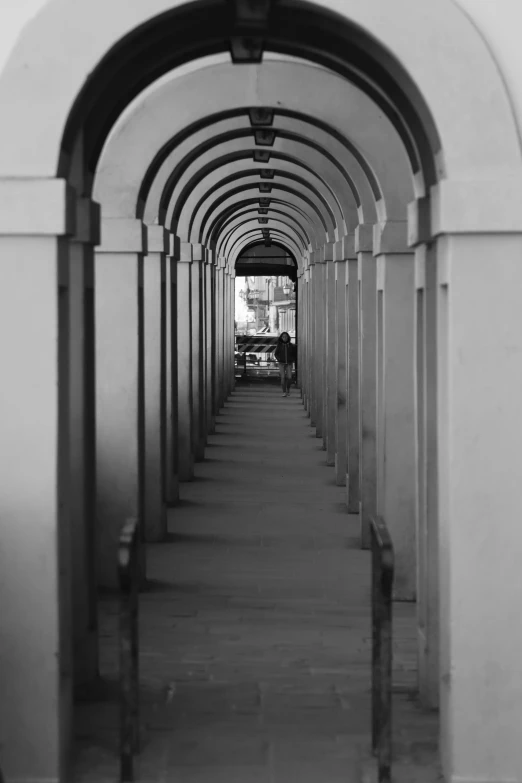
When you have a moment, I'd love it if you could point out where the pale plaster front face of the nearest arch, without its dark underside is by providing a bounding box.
[0,0,520,185]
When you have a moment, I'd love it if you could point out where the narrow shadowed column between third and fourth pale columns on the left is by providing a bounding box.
[163,234,179,506]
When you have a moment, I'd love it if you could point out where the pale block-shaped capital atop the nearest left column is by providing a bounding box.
[0,179,77,239]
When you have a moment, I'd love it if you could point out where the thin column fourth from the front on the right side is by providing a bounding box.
[343,234,361,514]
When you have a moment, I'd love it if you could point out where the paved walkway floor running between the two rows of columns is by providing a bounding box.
[75,385,437,783]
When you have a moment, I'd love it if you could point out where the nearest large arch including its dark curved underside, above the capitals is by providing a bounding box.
[0,0,520,193]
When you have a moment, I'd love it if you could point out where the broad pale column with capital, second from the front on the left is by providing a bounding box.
[95,218,147,588]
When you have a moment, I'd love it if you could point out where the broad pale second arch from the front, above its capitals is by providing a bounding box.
[95,62,412,224]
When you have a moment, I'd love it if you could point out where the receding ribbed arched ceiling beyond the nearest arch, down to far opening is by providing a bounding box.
[89,60,414,276]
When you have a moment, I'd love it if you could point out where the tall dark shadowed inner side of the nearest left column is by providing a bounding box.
[69,198,100,698]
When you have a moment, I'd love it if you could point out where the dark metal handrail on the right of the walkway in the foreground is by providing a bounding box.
[370,517,394,783]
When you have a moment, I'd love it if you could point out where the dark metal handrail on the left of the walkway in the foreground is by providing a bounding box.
[118,519,140,783]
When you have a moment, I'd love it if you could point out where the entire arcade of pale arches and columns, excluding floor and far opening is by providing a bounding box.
[0,0,522,783]
